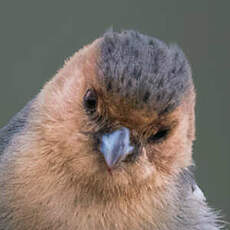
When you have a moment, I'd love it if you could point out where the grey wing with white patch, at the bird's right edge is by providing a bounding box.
[176,169,221,230]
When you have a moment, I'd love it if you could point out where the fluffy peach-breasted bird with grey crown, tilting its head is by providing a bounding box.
[0,30,221,230]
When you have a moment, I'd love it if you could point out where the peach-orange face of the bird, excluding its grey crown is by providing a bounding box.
[37,32,195,198]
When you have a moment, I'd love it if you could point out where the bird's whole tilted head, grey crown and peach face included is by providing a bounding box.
[37,31,195,197]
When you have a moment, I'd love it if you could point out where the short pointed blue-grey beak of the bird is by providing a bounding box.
[100,127,134,168]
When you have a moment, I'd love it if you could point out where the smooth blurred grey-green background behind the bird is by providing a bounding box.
[0,0,230,221]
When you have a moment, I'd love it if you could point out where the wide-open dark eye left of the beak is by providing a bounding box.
[83,89,97,113]
